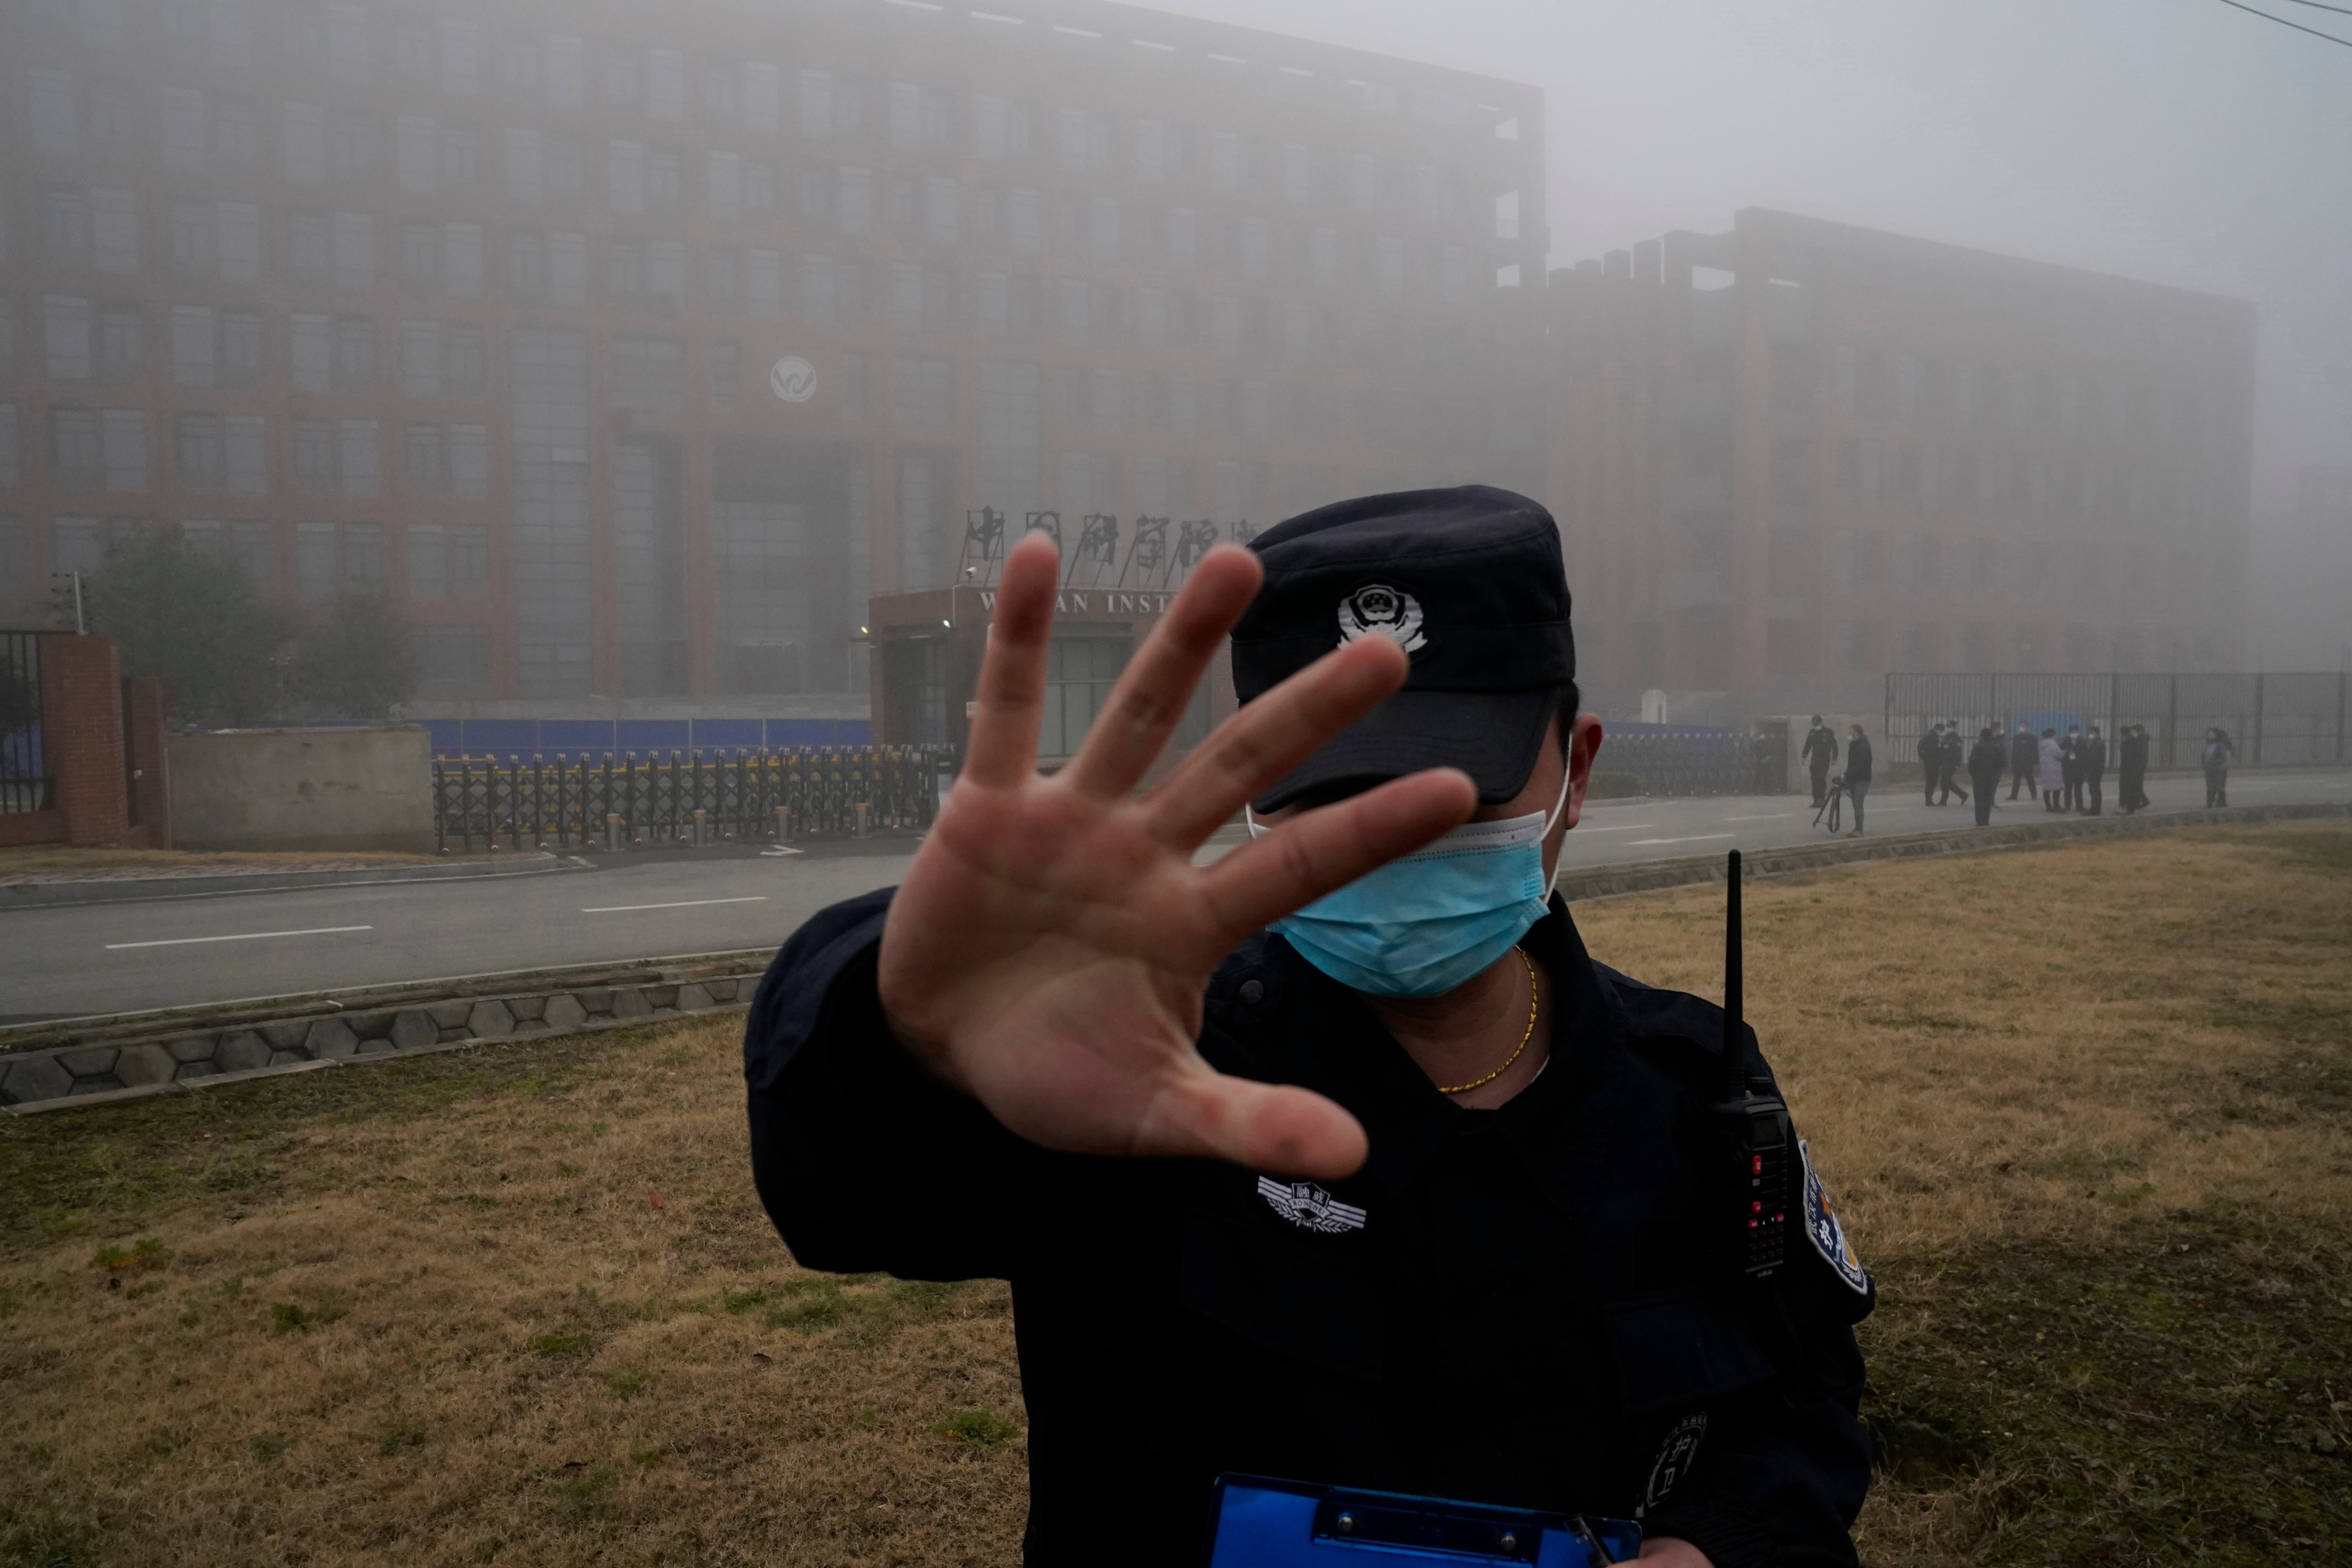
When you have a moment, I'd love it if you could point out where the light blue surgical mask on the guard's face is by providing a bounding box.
[1249,778,1569,997]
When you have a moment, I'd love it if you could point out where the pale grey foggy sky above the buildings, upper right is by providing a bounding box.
[1160,0,2352,512]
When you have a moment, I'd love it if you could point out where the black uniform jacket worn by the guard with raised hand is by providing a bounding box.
[743,891,1872,1568]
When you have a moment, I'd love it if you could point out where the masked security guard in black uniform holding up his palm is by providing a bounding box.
[746,486,1872,1568]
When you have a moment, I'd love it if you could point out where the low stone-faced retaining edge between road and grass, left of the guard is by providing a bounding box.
[0,971,760,1110]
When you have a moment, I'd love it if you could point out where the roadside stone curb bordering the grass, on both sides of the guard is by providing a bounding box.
[0,804,2352,1117]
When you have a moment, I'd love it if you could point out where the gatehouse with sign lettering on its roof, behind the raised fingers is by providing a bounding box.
[866,508,1251,778]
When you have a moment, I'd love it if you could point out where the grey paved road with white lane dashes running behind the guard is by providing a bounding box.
[0,769,2352,1023]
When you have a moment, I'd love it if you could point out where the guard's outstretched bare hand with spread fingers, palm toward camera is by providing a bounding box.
[880,534,1477,1178]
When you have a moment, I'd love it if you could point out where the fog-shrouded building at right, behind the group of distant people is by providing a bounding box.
[1548,209,2253,703]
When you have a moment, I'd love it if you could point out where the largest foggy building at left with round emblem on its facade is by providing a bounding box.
[0,0,1548,712]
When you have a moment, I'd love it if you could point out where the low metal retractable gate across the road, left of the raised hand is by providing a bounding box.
[433,745,955,851]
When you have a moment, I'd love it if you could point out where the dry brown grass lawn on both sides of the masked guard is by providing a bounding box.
[0,828,2352,1568]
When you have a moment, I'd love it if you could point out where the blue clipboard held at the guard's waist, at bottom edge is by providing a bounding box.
[1207,1474,1642,1568]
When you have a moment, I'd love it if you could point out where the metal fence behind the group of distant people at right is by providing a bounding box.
[1884,670,2352,769]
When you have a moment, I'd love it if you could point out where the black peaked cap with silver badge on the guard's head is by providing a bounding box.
[1232,484,1576,811]
